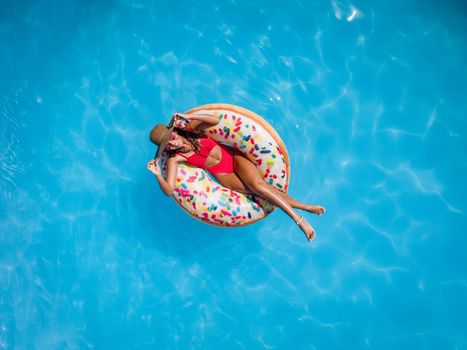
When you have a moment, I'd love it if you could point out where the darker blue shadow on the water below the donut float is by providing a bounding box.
[128,173,262,275]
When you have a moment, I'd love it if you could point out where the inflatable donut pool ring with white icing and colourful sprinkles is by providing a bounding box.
[161,104,290,227]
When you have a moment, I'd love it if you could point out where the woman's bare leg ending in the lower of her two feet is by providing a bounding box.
[234,154,315,240]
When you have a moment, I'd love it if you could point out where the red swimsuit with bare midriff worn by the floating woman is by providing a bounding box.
[177,137,234,174]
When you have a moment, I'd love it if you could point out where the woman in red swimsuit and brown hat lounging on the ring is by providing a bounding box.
[147,113,325,240]
